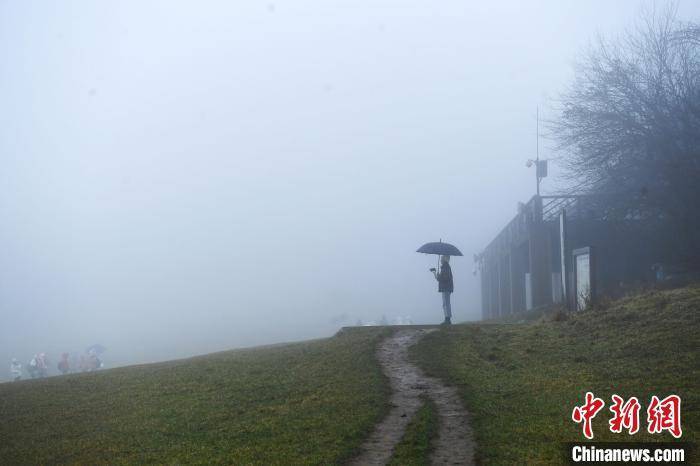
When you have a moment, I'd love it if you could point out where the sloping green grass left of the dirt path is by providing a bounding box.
[0,328,389,464]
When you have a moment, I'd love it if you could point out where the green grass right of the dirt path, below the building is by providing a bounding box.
[411,286,700,465]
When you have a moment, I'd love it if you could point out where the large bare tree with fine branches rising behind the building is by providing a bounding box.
[549,5,700,265]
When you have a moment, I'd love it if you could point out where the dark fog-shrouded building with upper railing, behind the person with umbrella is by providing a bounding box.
[475,196,679,319]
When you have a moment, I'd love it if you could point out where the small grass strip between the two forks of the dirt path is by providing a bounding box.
[389,399,438,466]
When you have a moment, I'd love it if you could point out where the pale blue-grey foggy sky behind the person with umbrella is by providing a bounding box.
[0,0,700,378]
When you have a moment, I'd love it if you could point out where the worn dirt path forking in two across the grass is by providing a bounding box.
[351,329,474,465]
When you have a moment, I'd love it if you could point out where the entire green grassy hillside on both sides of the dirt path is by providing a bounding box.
[0,286,700,465]
